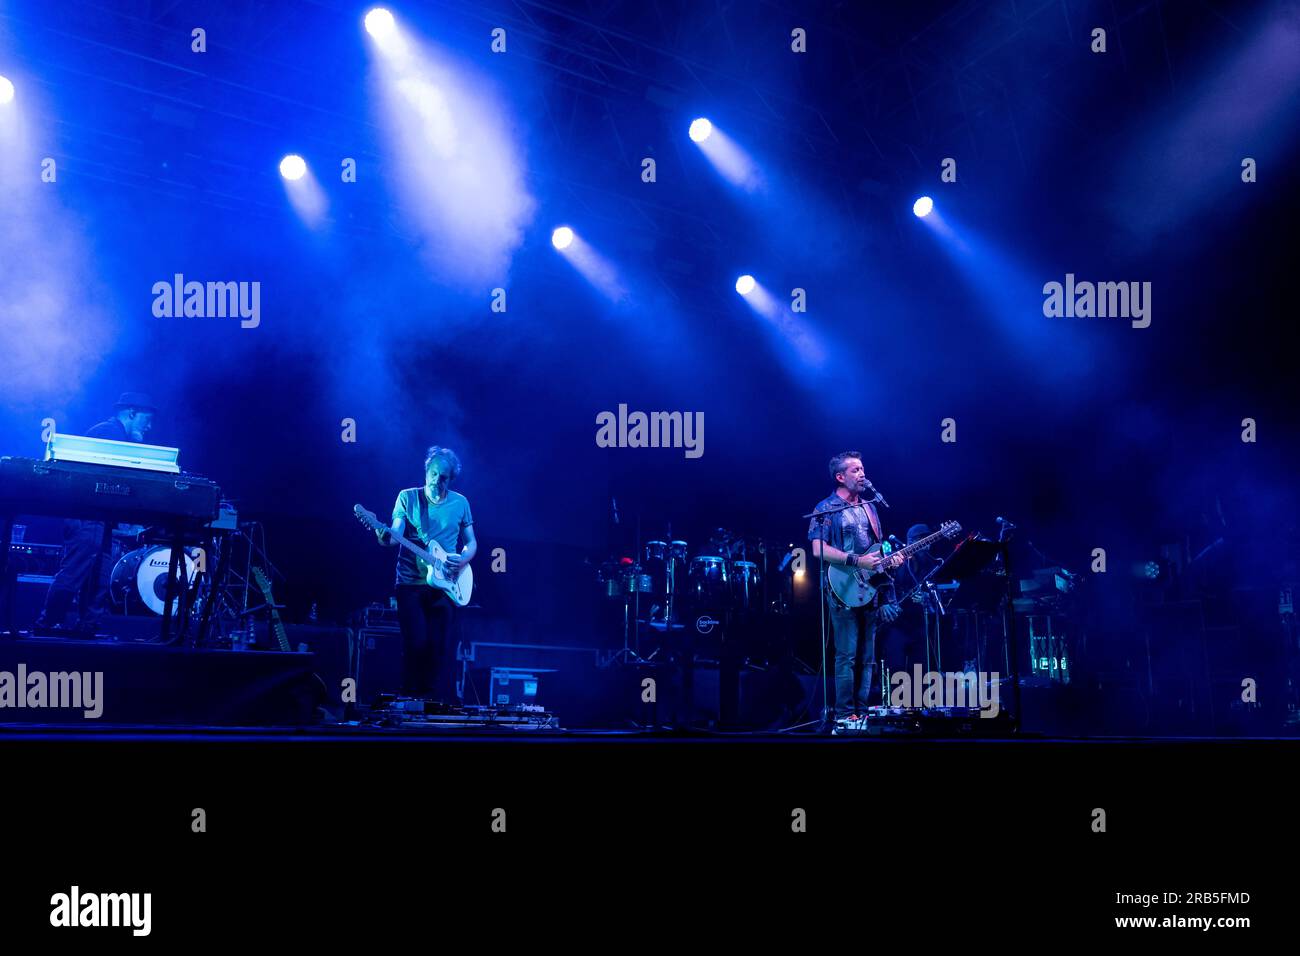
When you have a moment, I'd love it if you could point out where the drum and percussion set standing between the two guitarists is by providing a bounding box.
[597,528,784,657]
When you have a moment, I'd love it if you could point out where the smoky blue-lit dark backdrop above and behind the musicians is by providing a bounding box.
[0,0,1300,717]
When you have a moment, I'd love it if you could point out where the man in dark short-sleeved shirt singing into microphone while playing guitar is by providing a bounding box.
[809,451,901,723]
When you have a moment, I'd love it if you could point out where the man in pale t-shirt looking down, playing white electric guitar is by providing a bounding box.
[376,445,478,698]
